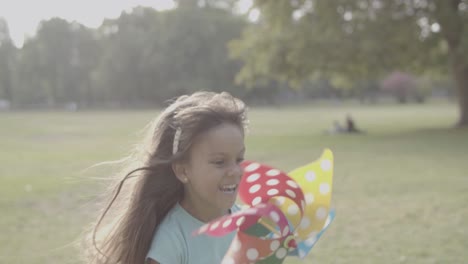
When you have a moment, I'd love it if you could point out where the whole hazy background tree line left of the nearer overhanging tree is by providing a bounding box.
[0,5,245,107]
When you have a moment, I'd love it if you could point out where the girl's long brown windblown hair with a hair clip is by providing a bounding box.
[87,92,250,264]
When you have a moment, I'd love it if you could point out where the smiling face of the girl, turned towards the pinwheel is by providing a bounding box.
[176,123,245,221]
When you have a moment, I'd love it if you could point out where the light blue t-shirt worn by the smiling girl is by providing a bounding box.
[146,203,239,264]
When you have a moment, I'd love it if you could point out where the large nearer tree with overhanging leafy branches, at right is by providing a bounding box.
[231,0,468,126]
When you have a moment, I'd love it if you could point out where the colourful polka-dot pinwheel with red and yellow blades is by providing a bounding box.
[194,149,334,264]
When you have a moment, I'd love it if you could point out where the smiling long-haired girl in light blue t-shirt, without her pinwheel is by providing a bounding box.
[89,92,246,264]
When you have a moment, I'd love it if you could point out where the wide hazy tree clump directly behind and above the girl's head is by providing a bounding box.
[96,2,244,105]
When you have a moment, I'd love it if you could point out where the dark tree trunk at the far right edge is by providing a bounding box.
[454,64,468,127]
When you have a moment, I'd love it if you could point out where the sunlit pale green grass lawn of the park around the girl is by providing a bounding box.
[0,104,468,264]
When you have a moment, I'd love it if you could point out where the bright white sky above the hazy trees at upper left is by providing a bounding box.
[0,0,252,47]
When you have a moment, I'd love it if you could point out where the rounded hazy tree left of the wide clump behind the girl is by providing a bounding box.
[15,18,100,107]
